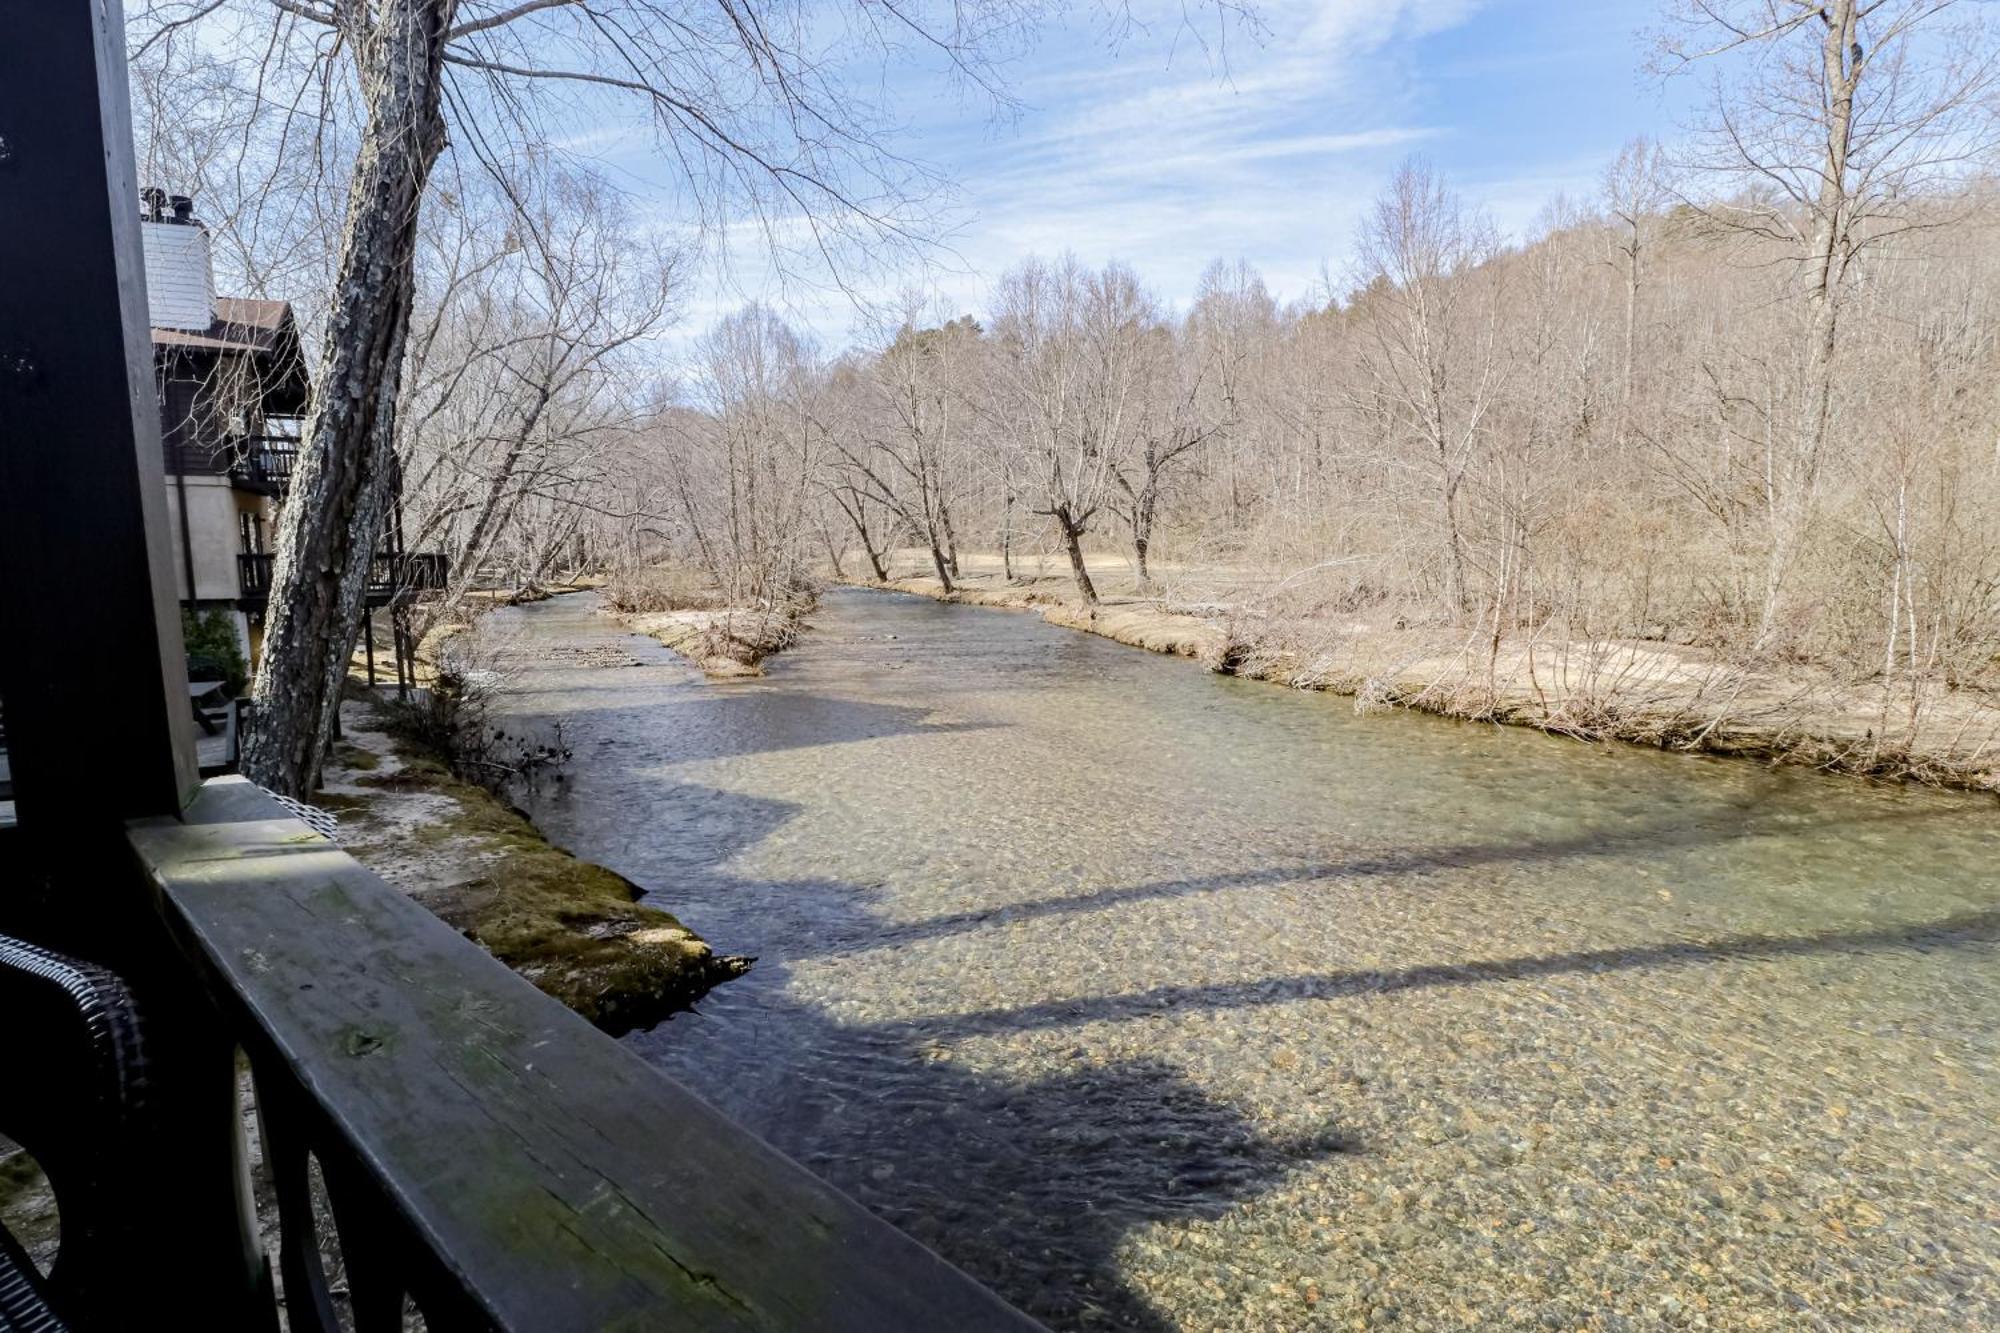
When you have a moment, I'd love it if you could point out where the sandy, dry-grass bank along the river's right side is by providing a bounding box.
[858,564,2000,793]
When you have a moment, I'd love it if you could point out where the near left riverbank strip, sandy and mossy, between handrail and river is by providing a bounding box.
[314,701,750,1035]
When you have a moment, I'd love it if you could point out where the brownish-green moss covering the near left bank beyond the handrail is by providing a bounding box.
[318,704,750,1035]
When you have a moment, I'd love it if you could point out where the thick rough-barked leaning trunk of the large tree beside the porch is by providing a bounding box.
[244,0,454,799]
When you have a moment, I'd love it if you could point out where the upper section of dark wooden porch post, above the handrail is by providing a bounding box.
[0,0,198,847]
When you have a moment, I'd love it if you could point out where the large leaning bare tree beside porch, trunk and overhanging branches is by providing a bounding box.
[134,0,1064,795]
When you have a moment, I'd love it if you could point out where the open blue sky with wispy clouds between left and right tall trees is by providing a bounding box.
[612,0,1688,346]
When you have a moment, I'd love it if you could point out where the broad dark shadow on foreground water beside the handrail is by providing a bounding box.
[656,967,1360,1333]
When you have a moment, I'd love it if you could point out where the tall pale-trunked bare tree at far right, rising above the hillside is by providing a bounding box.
[1662,0,2000,648]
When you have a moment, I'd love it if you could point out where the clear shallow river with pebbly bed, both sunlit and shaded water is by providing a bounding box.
[500,590,2000,1329]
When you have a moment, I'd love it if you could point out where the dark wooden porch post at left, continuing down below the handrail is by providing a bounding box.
[0,0,268,1329]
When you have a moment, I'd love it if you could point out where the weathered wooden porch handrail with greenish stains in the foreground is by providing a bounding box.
[128,779,1036,1333]
